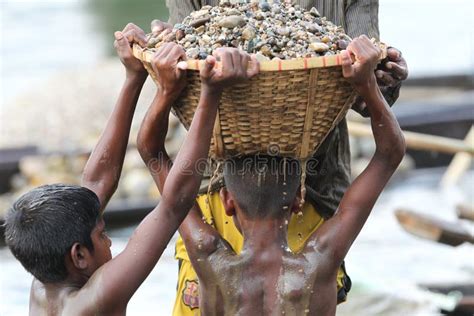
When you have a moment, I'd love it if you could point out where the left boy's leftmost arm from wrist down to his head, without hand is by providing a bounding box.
[82,74,144,209]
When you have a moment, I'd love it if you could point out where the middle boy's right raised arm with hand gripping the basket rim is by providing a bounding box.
[308,36,405,267]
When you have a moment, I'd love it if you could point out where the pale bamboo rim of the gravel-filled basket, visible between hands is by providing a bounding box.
[133,42,387,72]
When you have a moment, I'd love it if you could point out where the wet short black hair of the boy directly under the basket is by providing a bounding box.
[224,155,301,218]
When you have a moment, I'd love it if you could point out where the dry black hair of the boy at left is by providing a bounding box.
[5,184,100,283]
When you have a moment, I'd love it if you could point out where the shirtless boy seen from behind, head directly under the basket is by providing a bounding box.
[138,36,405,316]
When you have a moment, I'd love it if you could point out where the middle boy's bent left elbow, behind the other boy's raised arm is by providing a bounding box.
[137,93,173,193]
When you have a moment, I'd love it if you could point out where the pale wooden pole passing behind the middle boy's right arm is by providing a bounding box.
[347,122,474,156]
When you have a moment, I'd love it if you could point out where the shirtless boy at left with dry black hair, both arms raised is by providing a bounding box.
[5,24,258,315]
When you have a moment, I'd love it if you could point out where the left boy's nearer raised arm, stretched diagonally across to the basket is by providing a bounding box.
[91,45,260,312]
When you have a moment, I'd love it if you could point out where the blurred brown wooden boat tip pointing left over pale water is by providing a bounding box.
[395,209,474,247]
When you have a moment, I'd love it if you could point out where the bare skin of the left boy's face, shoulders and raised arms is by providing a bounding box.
[24,24,226,315]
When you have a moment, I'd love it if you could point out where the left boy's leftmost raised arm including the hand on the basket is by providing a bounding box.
[82,24,147,211]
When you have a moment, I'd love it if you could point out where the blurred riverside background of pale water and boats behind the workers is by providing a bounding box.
[0,0,474,315]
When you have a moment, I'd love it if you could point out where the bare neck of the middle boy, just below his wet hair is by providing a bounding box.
[241,218,288,254]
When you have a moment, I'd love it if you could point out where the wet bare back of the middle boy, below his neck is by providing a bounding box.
[193,243,337,316]
